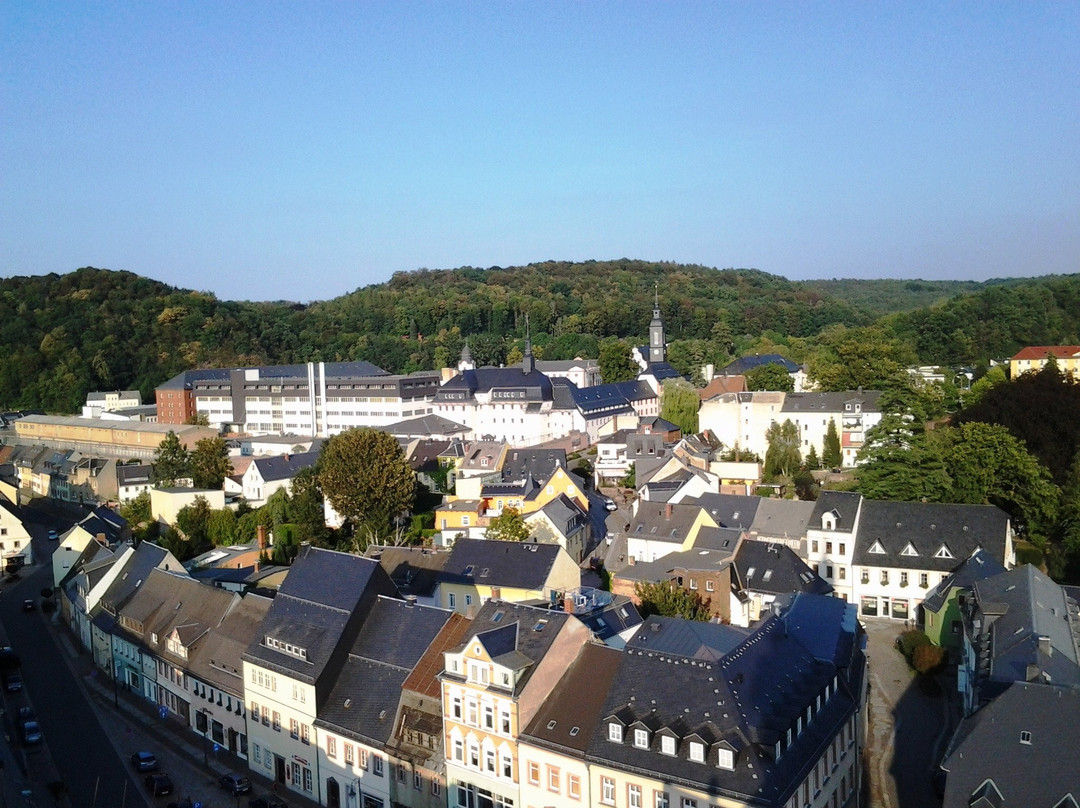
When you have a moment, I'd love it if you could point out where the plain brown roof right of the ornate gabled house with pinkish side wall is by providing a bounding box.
[519,645,622,758]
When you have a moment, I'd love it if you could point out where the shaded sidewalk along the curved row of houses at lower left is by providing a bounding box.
[48,620,319,808]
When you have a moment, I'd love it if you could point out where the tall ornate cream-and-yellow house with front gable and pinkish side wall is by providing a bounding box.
[440,600,591,808]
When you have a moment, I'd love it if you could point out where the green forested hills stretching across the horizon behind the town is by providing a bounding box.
[6,259,1080,413]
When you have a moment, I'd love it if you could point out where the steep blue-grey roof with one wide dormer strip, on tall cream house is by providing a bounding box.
[244,546,396,685]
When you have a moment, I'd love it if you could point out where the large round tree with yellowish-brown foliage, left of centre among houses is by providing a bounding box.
[316,429,416,535]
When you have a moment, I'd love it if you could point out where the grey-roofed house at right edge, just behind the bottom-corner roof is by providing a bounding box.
[957,564,1080,715]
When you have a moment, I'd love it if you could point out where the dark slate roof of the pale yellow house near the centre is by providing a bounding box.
[440,539,565,590]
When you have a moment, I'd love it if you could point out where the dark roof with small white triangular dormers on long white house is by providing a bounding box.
[851,500,1009,573]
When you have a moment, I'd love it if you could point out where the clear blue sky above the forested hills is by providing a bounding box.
[0,0,1080,301]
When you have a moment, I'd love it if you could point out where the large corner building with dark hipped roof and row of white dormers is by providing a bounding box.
[586,594,866,808]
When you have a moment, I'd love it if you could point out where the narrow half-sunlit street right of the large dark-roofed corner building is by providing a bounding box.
[863,618,960,808]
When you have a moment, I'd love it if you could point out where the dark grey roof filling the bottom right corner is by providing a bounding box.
[942,683,1080,808]
